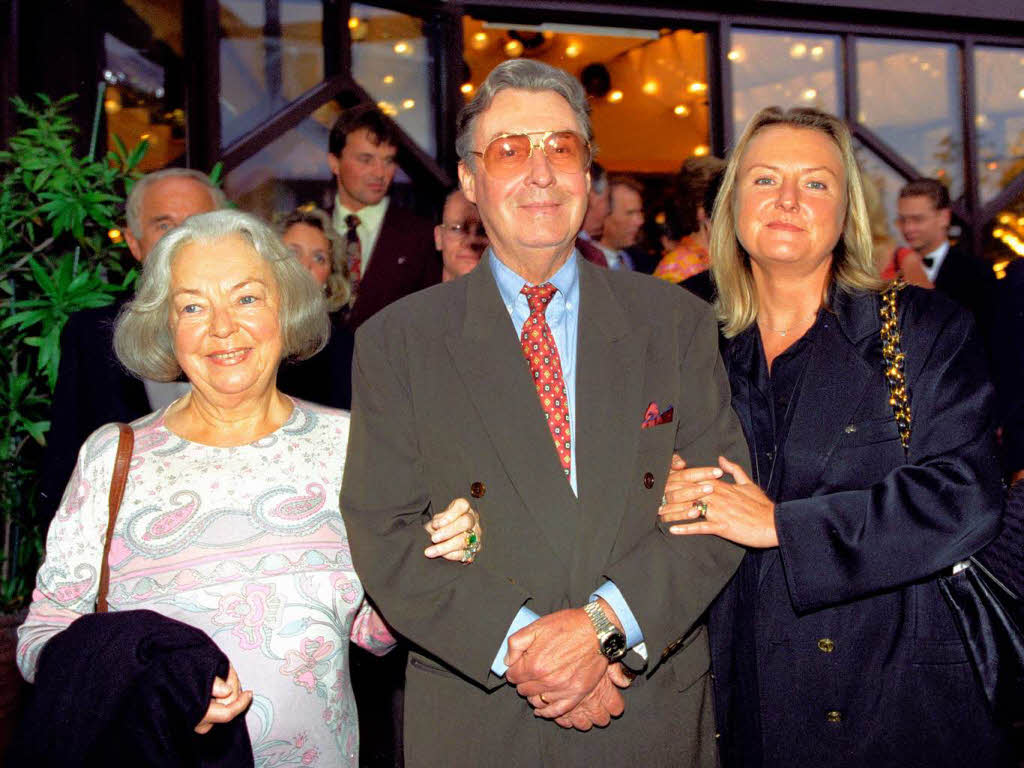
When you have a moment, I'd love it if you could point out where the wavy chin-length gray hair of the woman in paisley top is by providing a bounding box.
[114,210,331,381]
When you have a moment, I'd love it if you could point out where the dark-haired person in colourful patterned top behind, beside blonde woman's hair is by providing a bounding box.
[653,156,725,284]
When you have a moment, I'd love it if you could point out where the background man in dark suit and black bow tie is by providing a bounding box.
[896,178,993,325]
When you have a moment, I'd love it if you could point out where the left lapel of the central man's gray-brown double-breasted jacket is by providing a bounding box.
[447,259,579,564]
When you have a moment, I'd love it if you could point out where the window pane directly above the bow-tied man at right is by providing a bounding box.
[856,38,964,198]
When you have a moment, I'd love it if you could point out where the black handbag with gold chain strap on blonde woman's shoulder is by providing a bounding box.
[879,279,1024,723]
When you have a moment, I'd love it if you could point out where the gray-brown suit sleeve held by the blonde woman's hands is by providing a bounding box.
[605,296,750,671]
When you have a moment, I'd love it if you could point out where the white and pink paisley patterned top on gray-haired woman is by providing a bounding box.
[17,400,393,768]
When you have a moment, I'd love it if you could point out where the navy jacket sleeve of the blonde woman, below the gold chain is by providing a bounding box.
[775,303,1002,611]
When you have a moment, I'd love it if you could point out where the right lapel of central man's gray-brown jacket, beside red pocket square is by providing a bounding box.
[570,261,648,596]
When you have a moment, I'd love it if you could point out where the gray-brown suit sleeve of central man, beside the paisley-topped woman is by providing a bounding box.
[341,314,529,688]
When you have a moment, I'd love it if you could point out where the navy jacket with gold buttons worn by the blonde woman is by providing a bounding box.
[711,288,1006,768]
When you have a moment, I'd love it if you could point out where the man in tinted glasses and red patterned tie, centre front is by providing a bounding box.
[341,59,748,767]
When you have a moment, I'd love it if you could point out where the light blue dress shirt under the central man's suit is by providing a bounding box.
[487,249,643,676]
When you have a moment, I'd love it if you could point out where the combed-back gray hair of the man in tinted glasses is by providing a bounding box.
[455,58,594,168]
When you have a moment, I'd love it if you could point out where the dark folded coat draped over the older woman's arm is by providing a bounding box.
[6,610,253,768]
